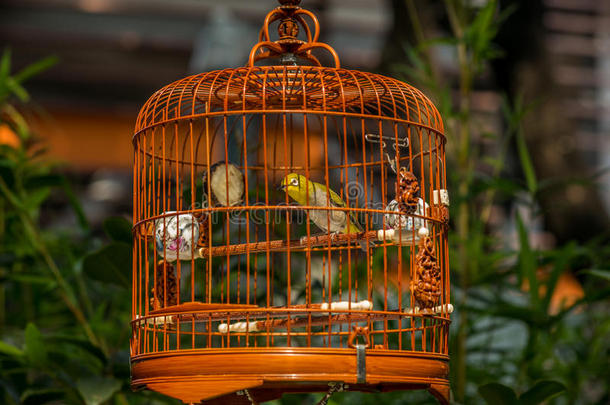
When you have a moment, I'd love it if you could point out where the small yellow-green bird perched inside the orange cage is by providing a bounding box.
[279,173,372,251]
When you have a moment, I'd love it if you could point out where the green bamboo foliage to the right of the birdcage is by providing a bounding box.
[396,0,610,404]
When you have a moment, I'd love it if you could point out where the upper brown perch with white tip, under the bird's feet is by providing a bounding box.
[198,228,428,258]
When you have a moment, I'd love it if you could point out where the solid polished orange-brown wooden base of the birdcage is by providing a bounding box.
[131,348,449,404]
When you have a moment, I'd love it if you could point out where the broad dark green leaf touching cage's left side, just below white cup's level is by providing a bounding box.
[83,242,132,287]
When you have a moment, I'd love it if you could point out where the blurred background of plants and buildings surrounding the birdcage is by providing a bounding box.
[0,0,610,404]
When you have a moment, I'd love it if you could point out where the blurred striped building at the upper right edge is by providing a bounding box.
[544,0,610,208]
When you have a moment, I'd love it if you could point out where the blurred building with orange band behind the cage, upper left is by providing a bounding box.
[0,0,391,223]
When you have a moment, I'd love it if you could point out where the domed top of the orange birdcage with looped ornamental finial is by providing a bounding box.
[136,0,444,136]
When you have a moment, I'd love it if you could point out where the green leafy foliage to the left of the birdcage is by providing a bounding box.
[0,51,175,405]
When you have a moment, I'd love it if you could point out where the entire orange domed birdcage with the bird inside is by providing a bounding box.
[131,0,453,404]
